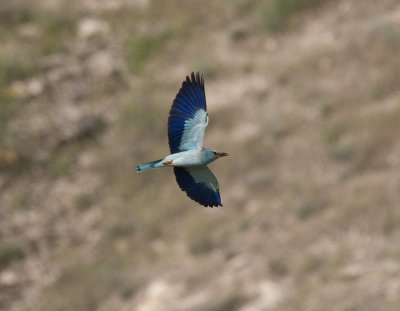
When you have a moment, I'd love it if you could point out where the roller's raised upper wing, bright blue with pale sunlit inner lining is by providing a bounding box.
[168,72,208,153]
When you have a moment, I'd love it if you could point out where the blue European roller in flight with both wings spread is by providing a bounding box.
[136,72,228,207]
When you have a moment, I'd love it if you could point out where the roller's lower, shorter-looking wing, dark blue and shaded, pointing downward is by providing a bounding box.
[174,165,222,207]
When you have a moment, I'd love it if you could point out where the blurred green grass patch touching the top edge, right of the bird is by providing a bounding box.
[258,0,327,32]
